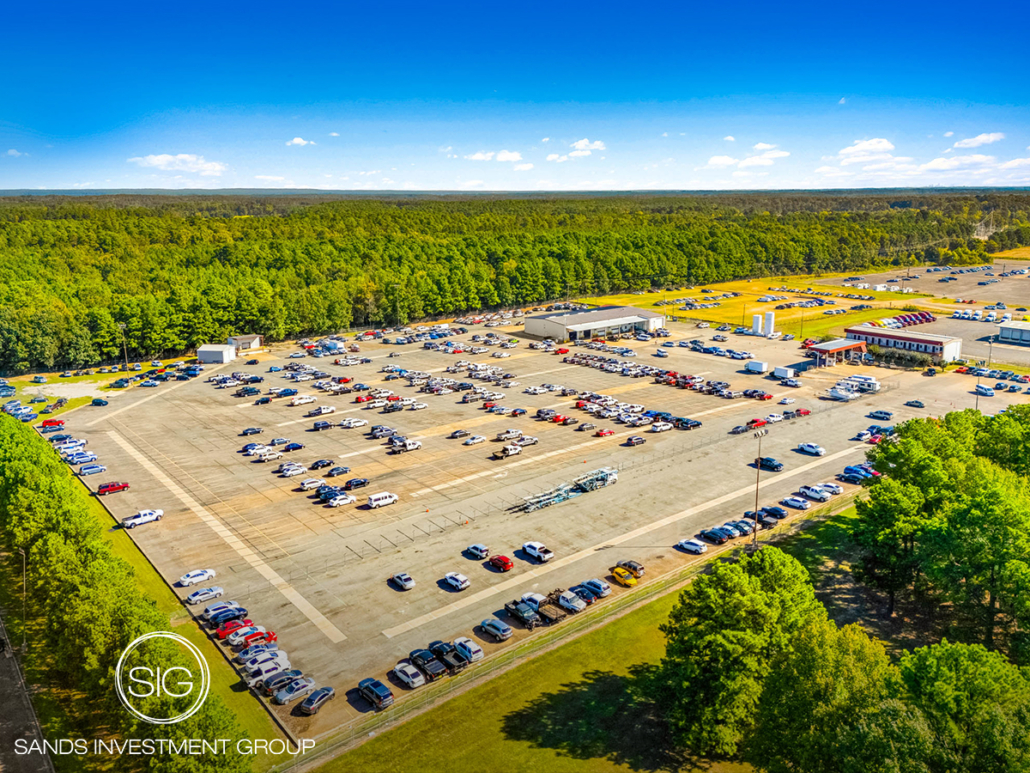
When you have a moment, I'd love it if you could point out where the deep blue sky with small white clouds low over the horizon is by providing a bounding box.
[0,2,1030,191]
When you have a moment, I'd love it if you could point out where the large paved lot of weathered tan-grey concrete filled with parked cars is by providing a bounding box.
[69,326,1028,737]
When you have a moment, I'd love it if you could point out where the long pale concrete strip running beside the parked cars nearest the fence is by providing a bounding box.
[382,445,866,639]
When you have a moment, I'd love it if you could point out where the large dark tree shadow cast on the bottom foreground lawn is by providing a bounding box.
[503,665,705,771]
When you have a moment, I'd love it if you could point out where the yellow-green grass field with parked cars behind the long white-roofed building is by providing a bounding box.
[581,276,927,338]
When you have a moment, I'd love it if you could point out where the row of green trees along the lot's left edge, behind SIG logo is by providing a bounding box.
[0,416,250,773]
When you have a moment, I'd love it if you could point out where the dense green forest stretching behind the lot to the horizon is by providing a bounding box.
[0,192,1030,373]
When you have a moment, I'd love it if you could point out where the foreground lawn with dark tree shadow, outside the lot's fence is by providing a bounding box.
[318,508,855,773]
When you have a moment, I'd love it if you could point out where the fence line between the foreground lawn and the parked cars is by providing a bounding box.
[269,491,859,773]
